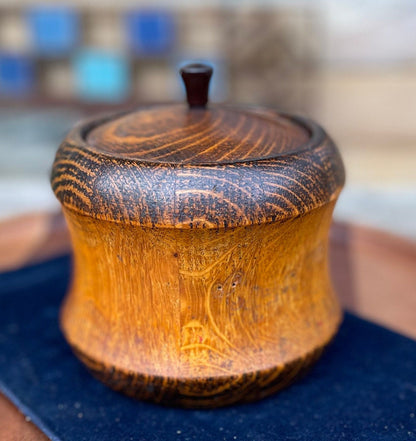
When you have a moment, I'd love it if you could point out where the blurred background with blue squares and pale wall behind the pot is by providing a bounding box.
[0,0,416,240]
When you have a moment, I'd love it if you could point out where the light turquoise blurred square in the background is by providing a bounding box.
[73,49,130,102]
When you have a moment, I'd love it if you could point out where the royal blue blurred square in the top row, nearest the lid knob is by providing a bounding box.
[126,10,175,56]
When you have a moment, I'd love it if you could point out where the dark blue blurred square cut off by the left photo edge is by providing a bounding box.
[0,53,35,95]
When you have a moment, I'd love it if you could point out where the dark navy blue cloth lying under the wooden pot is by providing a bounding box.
[0,257,416,441]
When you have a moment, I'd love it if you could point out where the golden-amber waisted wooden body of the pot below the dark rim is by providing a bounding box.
[61,204,340,406]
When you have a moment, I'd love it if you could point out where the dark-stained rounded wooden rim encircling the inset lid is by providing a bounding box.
[52,109,344,228]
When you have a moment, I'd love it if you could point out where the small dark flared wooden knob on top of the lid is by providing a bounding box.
[180,63,212,108]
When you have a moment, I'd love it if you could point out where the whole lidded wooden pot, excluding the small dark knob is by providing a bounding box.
[52,86,344,407]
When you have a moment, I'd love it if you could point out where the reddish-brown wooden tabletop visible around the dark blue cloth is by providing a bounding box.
[0,213,416,434]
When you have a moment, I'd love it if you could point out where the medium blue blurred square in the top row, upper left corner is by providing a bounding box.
[27,6,80,56]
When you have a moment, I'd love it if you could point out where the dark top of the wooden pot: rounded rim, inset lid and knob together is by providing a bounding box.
[52,65,344,228]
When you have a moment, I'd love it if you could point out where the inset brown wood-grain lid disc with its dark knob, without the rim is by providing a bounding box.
[86,64,310,164]
